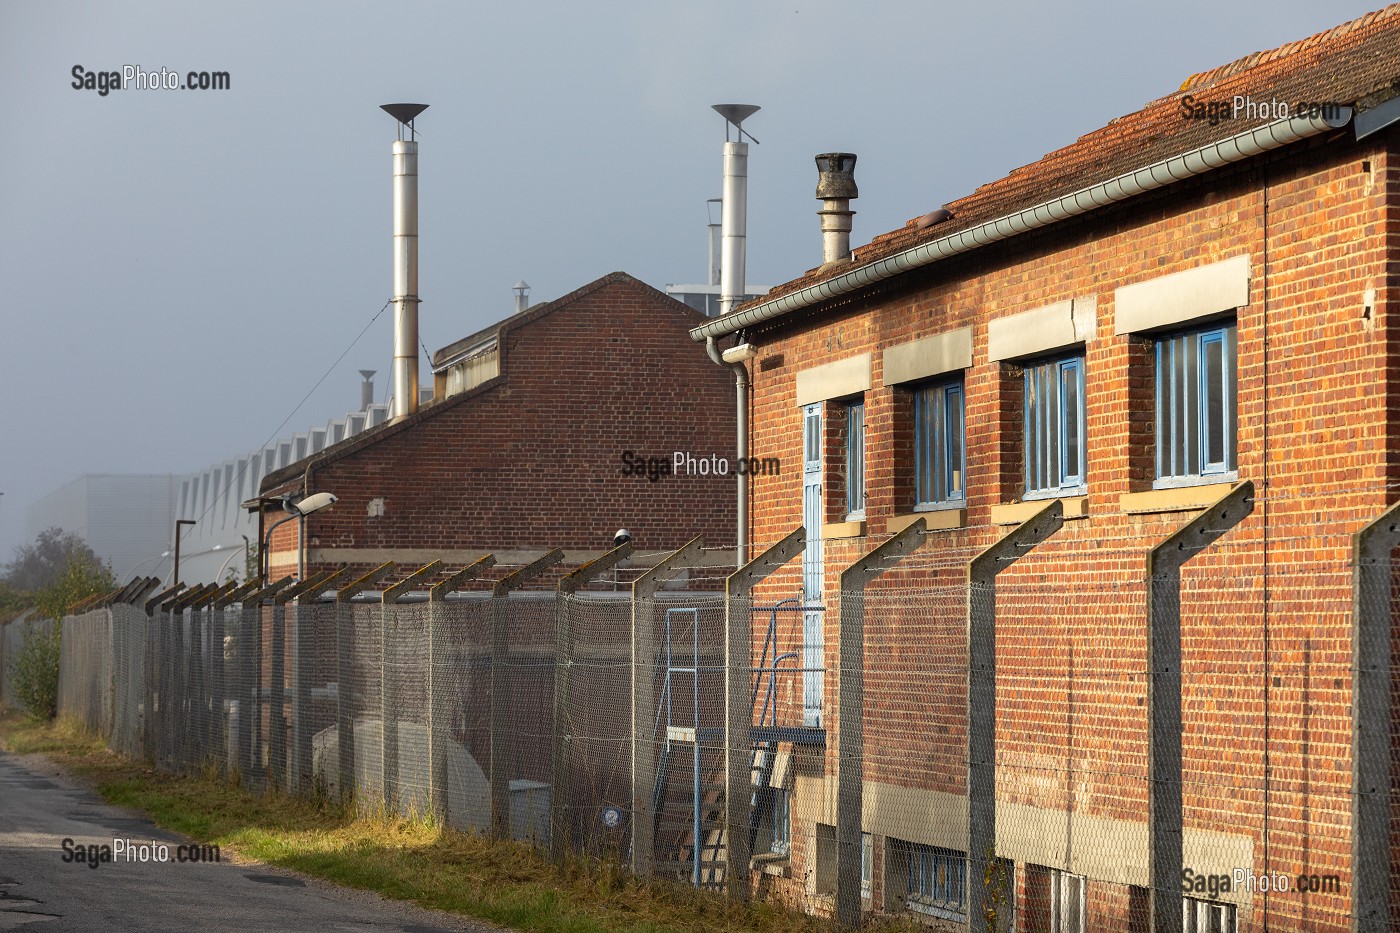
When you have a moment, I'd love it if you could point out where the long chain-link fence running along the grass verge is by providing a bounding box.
[38,518,1400,933]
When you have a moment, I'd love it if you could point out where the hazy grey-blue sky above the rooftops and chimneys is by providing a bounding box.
[0,0,1379,560]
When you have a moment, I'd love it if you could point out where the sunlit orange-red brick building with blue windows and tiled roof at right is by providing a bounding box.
[692,7,1400,933]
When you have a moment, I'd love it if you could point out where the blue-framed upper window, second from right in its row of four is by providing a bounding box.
[1025,356,1085,499]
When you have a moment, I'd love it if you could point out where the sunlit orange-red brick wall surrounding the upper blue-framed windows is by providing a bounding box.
[749,132,1400,930]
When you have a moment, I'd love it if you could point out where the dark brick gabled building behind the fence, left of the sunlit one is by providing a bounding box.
[262,272,734,579]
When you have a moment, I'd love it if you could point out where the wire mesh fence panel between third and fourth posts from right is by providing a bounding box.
[840,574,969,923]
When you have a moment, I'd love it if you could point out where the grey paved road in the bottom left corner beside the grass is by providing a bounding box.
[0,752,496,933]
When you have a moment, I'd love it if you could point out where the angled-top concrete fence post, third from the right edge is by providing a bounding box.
[966,499,1064,933]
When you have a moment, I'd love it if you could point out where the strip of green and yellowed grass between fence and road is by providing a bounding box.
[0,712,895,933]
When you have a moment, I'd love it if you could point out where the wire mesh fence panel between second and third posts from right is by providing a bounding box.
[991,563,1151,930]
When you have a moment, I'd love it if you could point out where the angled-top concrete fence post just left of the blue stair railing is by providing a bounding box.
[631,537,704,878]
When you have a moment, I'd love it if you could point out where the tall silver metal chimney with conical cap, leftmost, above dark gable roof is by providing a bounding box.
[379,104,428,417]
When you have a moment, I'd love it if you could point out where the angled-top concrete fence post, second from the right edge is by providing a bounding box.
[1147,481,1267,933]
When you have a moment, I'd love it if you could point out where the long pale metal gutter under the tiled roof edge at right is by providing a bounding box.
[690,106,1352,342]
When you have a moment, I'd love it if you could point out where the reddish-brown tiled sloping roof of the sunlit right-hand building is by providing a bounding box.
[742,3,1400,308]
